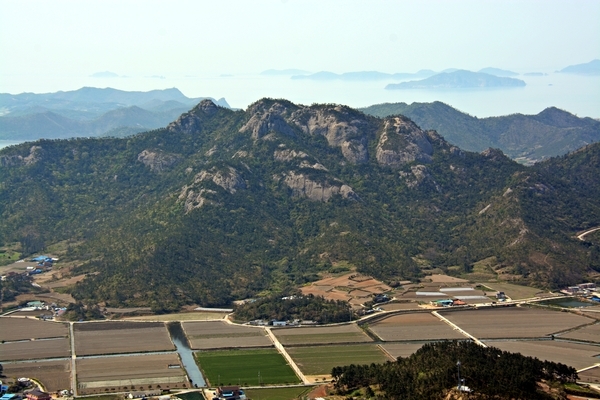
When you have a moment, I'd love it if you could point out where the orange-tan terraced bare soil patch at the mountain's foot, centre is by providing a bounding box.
[301,272,392,304]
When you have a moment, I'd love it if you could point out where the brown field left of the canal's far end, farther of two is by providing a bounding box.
[73,321,175,356]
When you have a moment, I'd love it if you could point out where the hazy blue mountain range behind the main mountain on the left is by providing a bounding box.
[0,87,229,140]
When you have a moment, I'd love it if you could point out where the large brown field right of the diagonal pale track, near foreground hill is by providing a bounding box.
[440,307,593,339]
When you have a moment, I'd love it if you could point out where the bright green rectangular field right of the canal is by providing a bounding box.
[196,349,300,386]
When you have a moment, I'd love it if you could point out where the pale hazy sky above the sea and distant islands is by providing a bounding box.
[0,0,600,112]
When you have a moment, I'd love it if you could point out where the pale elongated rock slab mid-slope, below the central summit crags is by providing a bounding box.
[283,171,358,201]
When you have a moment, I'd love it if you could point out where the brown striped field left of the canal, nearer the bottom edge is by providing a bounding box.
[76,353,189,394]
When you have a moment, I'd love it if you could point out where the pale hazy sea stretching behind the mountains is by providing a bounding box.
[0,72,600,146]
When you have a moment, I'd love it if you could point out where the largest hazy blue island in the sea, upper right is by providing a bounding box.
[385,70,525,90]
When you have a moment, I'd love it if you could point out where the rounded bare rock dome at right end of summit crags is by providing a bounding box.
[376,117,433,168]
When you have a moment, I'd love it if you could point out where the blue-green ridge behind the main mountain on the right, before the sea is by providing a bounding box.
[361,101,600,163]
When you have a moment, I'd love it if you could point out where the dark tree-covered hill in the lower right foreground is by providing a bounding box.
[331,341,578,400]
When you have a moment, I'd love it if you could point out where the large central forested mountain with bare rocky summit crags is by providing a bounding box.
[0,99,600,311]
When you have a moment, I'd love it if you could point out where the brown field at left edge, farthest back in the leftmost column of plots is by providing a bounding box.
[0,317,69,342]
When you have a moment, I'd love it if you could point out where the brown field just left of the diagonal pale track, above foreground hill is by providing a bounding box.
[369,313,465,341]
